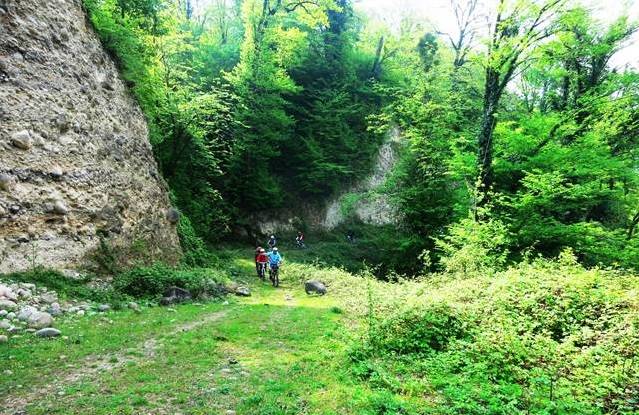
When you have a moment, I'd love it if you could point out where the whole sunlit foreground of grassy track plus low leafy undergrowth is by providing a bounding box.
[0,250,639,415]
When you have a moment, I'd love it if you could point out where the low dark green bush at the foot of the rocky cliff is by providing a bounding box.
[113,264,225,298]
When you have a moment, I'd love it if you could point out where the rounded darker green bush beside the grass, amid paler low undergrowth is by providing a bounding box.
[373,304,465,354]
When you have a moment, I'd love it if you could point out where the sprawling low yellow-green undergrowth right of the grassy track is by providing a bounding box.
[348,258,639,414]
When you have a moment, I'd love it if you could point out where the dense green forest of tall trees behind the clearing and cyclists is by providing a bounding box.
[85,0,639,271]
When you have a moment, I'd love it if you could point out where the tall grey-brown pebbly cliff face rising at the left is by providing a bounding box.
[0,0,180,272]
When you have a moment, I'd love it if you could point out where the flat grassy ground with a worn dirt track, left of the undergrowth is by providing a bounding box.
[0,263,378,415]
